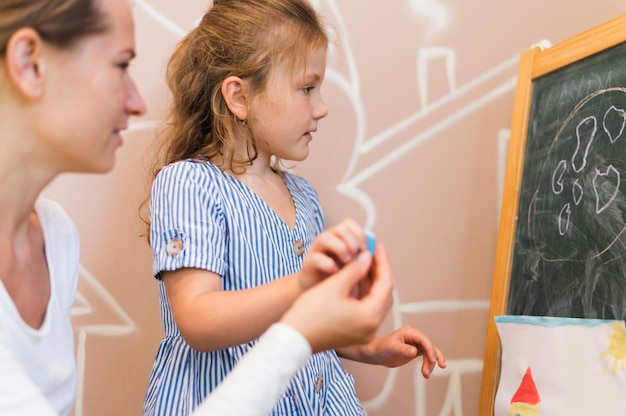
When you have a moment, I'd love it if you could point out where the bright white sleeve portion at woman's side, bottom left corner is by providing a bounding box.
[0,322,58,416]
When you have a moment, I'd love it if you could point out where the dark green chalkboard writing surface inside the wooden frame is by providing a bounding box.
[507,44,626,319]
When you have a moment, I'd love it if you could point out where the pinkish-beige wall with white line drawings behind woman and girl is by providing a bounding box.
[47,0,624,416]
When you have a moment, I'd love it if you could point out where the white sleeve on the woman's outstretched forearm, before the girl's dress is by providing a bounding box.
[192,323,312,416]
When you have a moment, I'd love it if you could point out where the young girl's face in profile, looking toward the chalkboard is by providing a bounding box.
[248,48,328,161]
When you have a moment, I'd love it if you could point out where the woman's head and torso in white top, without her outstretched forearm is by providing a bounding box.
[0,0,145,415]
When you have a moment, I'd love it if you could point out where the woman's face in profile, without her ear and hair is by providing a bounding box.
[38,0,145,173]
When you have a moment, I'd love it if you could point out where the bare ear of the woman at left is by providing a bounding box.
[6,27,45,99]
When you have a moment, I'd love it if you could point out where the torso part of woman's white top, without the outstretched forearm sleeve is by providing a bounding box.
[0,198,80,416]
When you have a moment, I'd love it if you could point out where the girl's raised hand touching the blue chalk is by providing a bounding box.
[300,219,367,290]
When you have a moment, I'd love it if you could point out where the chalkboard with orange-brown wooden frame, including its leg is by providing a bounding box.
[479,15,626,415]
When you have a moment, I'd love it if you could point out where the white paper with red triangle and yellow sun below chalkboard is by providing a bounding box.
[494,315,626,416]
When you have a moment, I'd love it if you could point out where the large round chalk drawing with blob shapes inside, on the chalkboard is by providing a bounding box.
[527,87,626,261]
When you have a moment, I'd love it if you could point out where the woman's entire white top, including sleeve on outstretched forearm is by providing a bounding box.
[0,199,311,416]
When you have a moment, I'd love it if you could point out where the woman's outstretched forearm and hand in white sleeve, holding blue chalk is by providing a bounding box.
[193,248,393,416]
